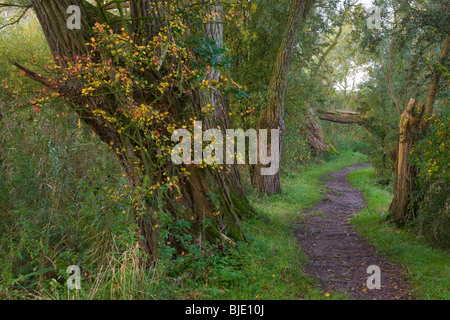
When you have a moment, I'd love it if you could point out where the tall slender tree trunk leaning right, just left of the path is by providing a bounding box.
[254,0,314,195]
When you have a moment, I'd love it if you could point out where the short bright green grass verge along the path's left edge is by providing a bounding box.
[146,152,367,300]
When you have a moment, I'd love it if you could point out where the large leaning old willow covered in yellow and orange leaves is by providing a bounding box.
[5,0,252,257]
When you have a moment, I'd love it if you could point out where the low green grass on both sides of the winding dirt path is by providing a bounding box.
[9,152,450,300]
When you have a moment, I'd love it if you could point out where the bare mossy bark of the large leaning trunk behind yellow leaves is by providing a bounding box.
[23,0,252,256]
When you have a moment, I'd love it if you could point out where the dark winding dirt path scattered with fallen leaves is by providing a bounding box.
[295,164,411,300]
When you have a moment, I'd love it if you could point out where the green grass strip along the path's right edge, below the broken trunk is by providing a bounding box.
[348,168,450,300]
